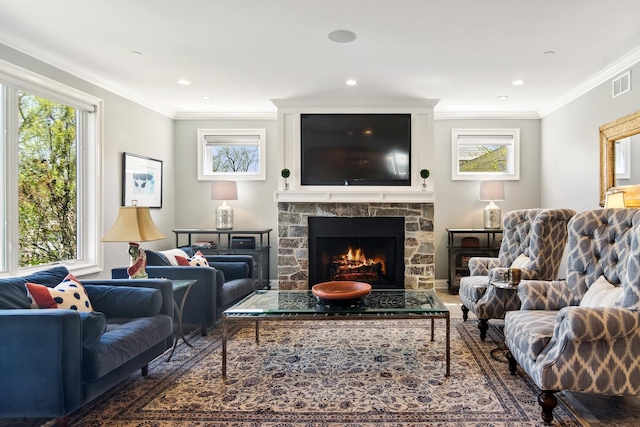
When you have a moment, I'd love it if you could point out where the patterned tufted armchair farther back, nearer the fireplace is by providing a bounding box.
[459,209,575,340]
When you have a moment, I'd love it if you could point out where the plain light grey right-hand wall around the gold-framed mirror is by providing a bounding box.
[540,61,640,212]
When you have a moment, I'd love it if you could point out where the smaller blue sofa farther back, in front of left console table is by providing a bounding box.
[111,251,255,336]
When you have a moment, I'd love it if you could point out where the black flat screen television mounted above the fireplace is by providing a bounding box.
[300,114,411,186]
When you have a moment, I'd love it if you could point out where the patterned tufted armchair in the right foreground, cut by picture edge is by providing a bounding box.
[504,209,640,423]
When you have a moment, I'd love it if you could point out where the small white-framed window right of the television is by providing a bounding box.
[451,129,520,180]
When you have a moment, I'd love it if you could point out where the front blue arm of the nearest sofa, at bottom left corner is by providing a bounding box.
[0,309,82,417]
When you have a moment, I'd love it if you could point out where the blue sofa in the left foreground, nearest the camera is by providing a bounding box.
[0,266,173,426]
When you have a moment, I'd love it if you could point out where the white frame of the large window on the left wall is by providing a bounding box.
[0,60,103,277]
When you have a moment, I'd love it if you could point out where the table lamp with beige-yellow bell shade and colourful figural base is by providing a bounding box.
[101,200,166,279]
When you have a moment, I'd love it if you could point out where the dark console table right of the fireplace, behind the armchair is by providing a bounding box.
[447,228,502,294]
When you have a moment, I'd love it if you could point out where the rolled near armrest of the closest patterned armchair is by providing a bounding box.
[554,306,640,341]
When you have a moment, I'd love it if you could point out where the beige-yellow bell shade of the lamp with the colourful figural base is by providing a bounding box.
[102,206,166,242]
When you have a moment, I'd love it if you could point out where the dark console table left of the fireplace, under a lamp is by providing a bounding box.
[173,228,272,289]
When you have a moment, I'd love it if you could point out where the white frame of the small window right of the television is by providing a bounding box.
[451,128,520,181]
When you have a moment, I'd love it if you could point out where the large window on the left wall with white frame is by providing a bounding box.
[0,62,101,275]
